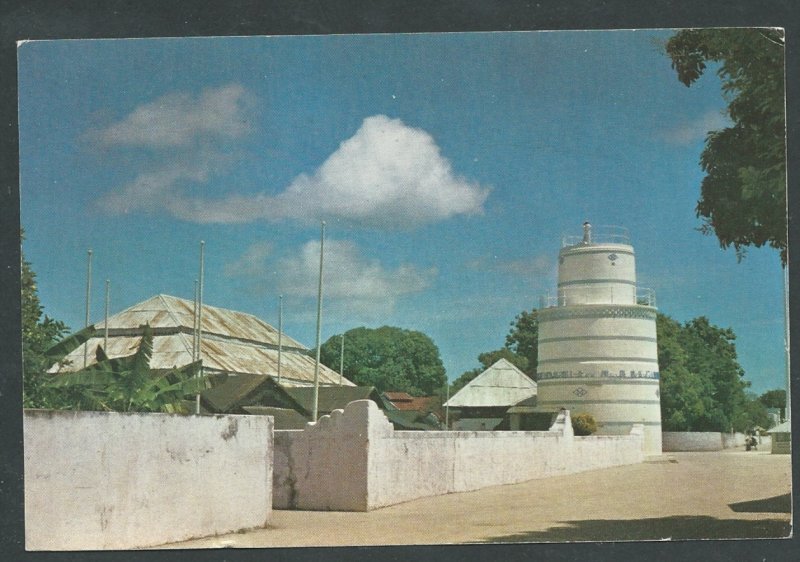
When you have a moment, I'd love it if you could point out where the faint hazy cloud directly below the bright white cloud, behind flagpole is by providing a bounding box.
[225,240,437,314]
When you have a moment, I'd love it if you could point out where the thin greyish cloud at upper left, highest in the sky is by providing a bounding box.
[87,84,253,148]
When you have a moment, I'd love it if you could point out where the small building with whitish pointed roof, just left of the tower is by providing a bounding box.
[445,359,537,431]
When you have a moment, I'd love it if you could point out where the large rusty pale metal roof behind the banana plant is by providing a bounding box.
[48,295,355,386]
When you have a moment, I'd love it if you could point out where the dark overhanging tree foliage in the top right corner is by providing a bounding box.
[666,28,787,266]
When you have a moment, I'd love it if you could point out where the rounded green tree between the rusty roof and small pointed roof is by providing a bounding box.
[320,326,446,395]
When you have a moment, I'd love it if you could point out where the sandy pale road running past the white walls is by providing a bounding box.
[161,449,791,548]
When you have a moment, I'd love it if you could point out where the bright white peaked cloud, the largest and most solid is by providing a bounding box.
[265,115,489,228]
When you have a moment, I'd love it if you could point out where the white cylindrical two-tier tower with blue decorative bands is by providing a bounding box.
[537,223,661,455]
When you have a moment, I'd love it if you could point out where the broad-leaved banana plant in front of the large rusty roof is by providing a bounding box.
[48,326,209,413]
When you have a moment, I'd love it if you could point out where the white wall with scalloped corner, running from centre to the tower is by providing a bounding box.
[273,400,644,511]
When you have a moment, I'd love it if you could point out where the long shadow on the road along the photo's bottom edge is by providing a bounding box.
[480,516,791,542]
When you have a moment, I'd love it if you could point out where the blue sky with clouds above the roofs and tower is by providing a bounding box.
[18,31,785,393]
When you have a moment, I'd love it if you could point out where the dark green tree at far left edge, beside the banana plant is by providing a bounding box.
[20,237,70,408]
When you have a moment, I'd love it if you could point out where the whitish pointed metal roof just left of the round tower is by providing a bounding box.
[445,359,536,408]
